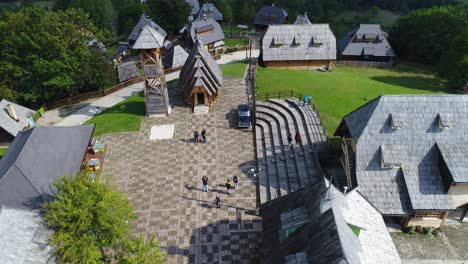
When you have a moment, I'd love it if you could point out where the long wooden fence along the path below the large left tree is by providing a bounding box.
[47,77,143,109]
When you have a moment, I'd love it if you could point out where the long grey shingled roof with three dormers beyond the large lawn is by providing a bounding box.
[262,24,336,61]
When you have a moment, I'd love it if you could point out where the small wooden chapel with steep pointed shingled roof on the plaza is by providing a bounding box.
[179,35,223,113]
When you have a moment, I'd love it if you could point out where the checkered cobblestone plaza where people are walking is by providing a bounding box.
[102,78,262,263]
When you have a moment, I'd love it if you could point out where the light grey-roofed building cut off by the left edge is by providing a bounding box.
[0,99,34,146]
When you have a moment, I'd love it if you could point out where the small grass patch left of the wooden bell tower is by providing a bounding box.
[85,92,145,136]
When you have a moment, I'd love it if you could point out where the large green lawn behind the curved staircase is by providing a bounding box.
[257,65,444,136]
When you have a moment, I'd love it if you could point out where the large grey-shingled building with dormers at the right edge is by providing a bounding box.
[335,95,468,227]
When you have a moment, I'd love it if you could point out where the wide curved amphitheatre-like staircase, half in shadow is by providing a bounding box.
[255,98,327,203]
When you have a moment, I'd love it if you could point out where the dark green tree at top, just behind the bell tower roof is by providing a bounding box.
[146,0,192,34]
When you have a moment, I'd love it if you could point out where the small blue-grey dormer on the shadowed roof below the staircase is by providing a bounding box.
[280,206,309,240]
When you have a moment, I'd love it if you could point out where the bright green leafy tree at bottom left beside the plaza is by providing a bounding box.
[44,175,165,264]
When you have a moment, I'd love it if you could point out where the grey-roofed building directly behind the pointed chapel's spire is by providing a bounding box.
[183,17,225,55]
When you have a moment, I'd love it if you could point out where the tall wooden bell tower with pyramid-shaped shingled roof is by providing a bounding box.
[133,25,170,116]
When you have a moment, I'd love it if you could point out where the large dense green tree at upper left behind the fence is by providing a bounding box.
[0,7,115,107]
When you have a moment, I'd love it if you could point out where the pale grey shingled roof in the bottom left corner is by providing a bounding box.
[0,206,54,264]
